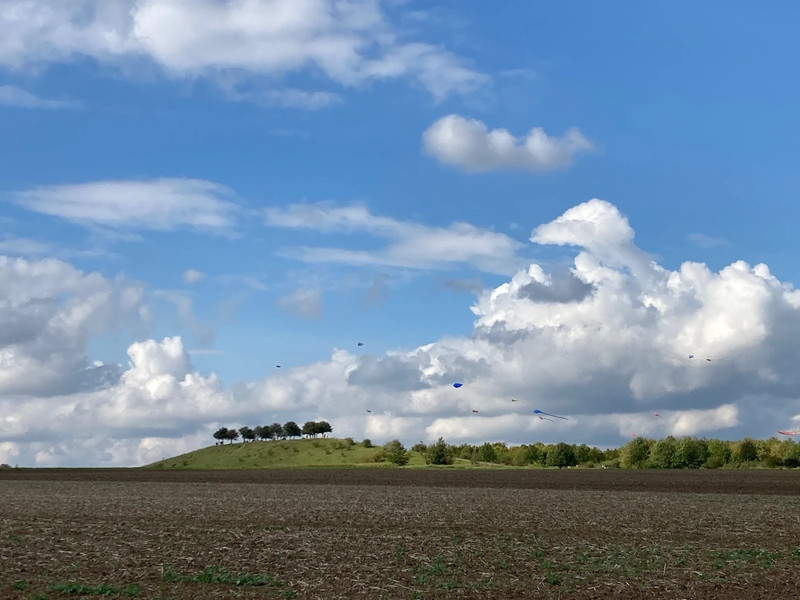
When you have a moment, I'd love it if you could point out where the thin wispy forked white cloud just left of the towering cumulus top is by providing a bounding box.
[265,202,522,274]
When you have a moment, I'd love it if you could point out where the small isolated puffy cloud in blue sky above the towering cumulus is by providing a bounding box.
[422,115,592,173]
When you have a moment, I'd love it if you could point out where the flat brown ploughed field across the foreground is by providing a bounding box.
[0,468,800,600]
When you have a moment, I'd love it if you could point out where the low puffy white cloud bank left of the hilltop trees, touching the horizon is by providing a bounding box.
[0,337,238,466]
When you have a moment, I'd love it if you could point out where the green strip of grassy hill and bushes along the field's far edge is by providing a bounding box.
[147,436,800,472]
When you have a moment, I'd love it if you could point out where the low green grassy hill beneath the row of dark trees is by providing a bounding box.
[143,438,432,469]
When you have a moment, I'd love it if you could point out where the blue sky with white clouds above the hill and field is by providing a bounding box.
[0,0,800,466]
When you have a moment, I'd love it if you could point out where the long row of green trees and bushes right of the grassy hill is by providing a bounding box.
[394,436,800,469]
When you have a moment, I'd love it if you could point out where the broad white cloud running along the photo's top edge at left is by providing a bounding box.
[0,0,487,105]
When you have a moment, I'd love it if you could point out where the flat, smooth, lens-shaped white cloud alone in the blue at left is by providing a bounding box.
[12,178,240,234]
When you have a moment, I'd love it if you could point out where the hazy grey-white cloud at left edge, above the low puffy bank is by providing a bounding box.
[0,256,147,397]
